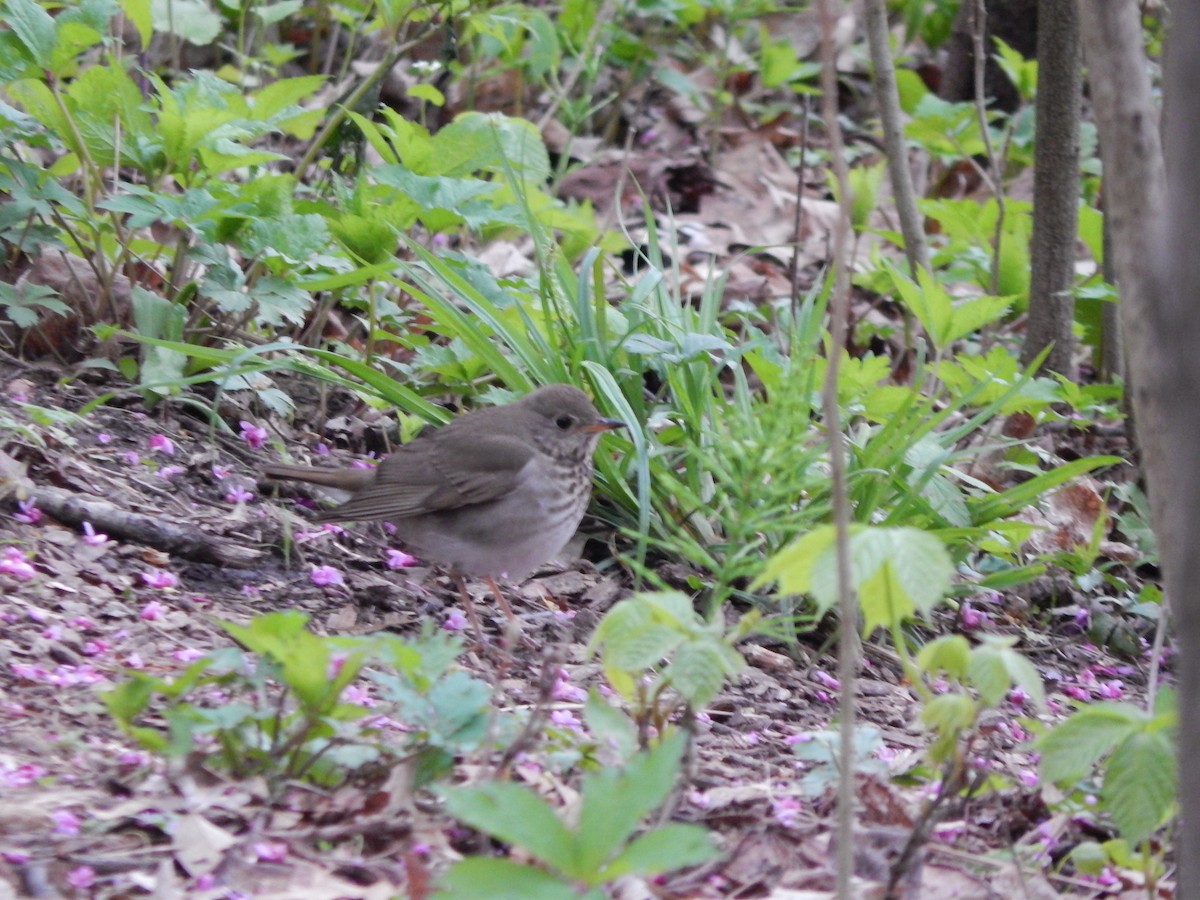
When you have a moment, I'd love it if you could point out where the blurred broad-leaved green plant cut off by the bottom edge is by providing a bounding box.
[437,733,716,900]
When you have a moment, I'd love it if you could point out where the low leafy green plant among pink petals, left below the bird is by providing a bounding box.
[103,612,491,788]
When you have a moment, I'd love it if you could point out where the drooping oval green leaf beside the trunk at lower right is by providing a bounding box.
[1100,731,1177,844]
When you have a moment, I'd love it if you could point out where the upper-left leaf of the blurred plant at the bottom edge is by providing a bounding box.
[442,781,578,874]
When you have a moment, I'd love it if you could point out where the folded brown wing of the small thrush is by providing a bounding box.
[330,430,535,520]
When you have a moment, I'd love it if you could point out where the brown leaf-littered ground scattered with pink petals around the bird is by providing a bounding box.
[0,352,1164,899]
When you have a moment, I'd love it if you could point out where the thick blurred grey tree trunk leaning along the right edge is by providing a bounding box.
[1080,0,1200,898]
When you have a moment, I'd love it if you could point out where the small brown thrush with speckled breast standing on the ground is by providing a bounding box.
[263,384,626,640]
